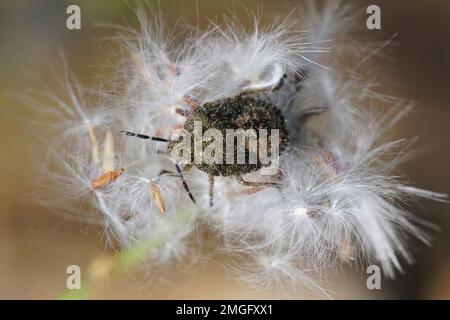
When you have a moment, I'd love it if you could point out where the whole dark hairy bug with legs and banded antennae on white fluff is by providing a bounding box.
[122,75,298,206]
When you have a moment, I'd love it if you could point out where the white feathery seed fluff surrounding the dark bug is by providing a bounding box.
[28,1,443,296]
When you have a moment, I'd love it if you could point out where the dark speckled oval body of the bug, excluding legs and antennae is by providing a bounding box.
[169,96,288,176]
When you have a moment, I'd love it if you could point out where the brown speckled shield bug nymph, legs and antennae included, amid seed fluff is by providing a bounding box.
[124,87,288,207]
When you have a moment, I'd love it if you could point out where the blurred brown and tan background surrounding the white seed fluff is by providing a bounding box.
[0,0,450,299]
